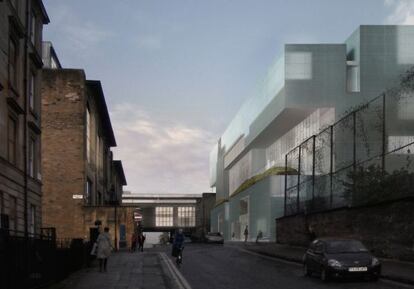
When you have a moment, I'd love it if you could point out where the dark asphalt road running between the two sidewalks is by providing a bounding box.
[163,244,414,289]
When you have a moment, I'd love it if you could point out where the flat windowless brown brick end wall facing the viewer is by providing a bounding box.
[42,69,86,238]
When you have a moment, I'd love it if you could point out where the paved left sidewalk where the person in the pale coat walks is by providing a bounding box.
[48,251,176,289]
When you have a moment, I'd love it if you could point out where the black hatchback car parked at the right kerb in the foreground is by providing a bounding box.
[303,238,381,281]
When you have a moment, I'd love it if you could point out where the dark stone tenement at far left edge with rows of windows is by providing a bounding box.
[0,0,49,236]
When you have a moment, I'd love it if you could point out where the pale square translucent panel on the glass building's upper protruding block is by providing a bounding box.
[286,52,312,79]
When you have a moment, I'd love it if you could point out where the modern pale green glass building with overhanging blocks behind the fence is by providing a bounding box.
[210,25,414,240]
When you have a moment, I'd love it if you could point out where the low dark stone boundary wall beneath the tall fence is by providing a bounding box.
[276,199,414,261]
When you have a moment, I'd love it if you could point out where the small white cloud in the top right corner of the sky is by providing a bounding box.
[384,0,414,25]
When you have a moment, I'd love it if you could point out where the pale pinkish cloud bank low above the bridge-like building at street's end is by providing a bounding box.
[111,104,216,194]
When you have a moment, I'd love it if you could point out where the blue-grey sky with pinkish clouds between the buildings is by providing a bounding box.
[43,0,414,194]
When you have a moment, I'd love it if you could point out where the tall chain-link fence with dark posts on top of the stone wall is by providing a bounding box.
[285,72,414,215]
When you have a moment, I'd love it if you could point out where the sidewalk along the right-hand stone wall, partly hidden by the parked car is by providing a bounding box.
[226,242,414,285]
